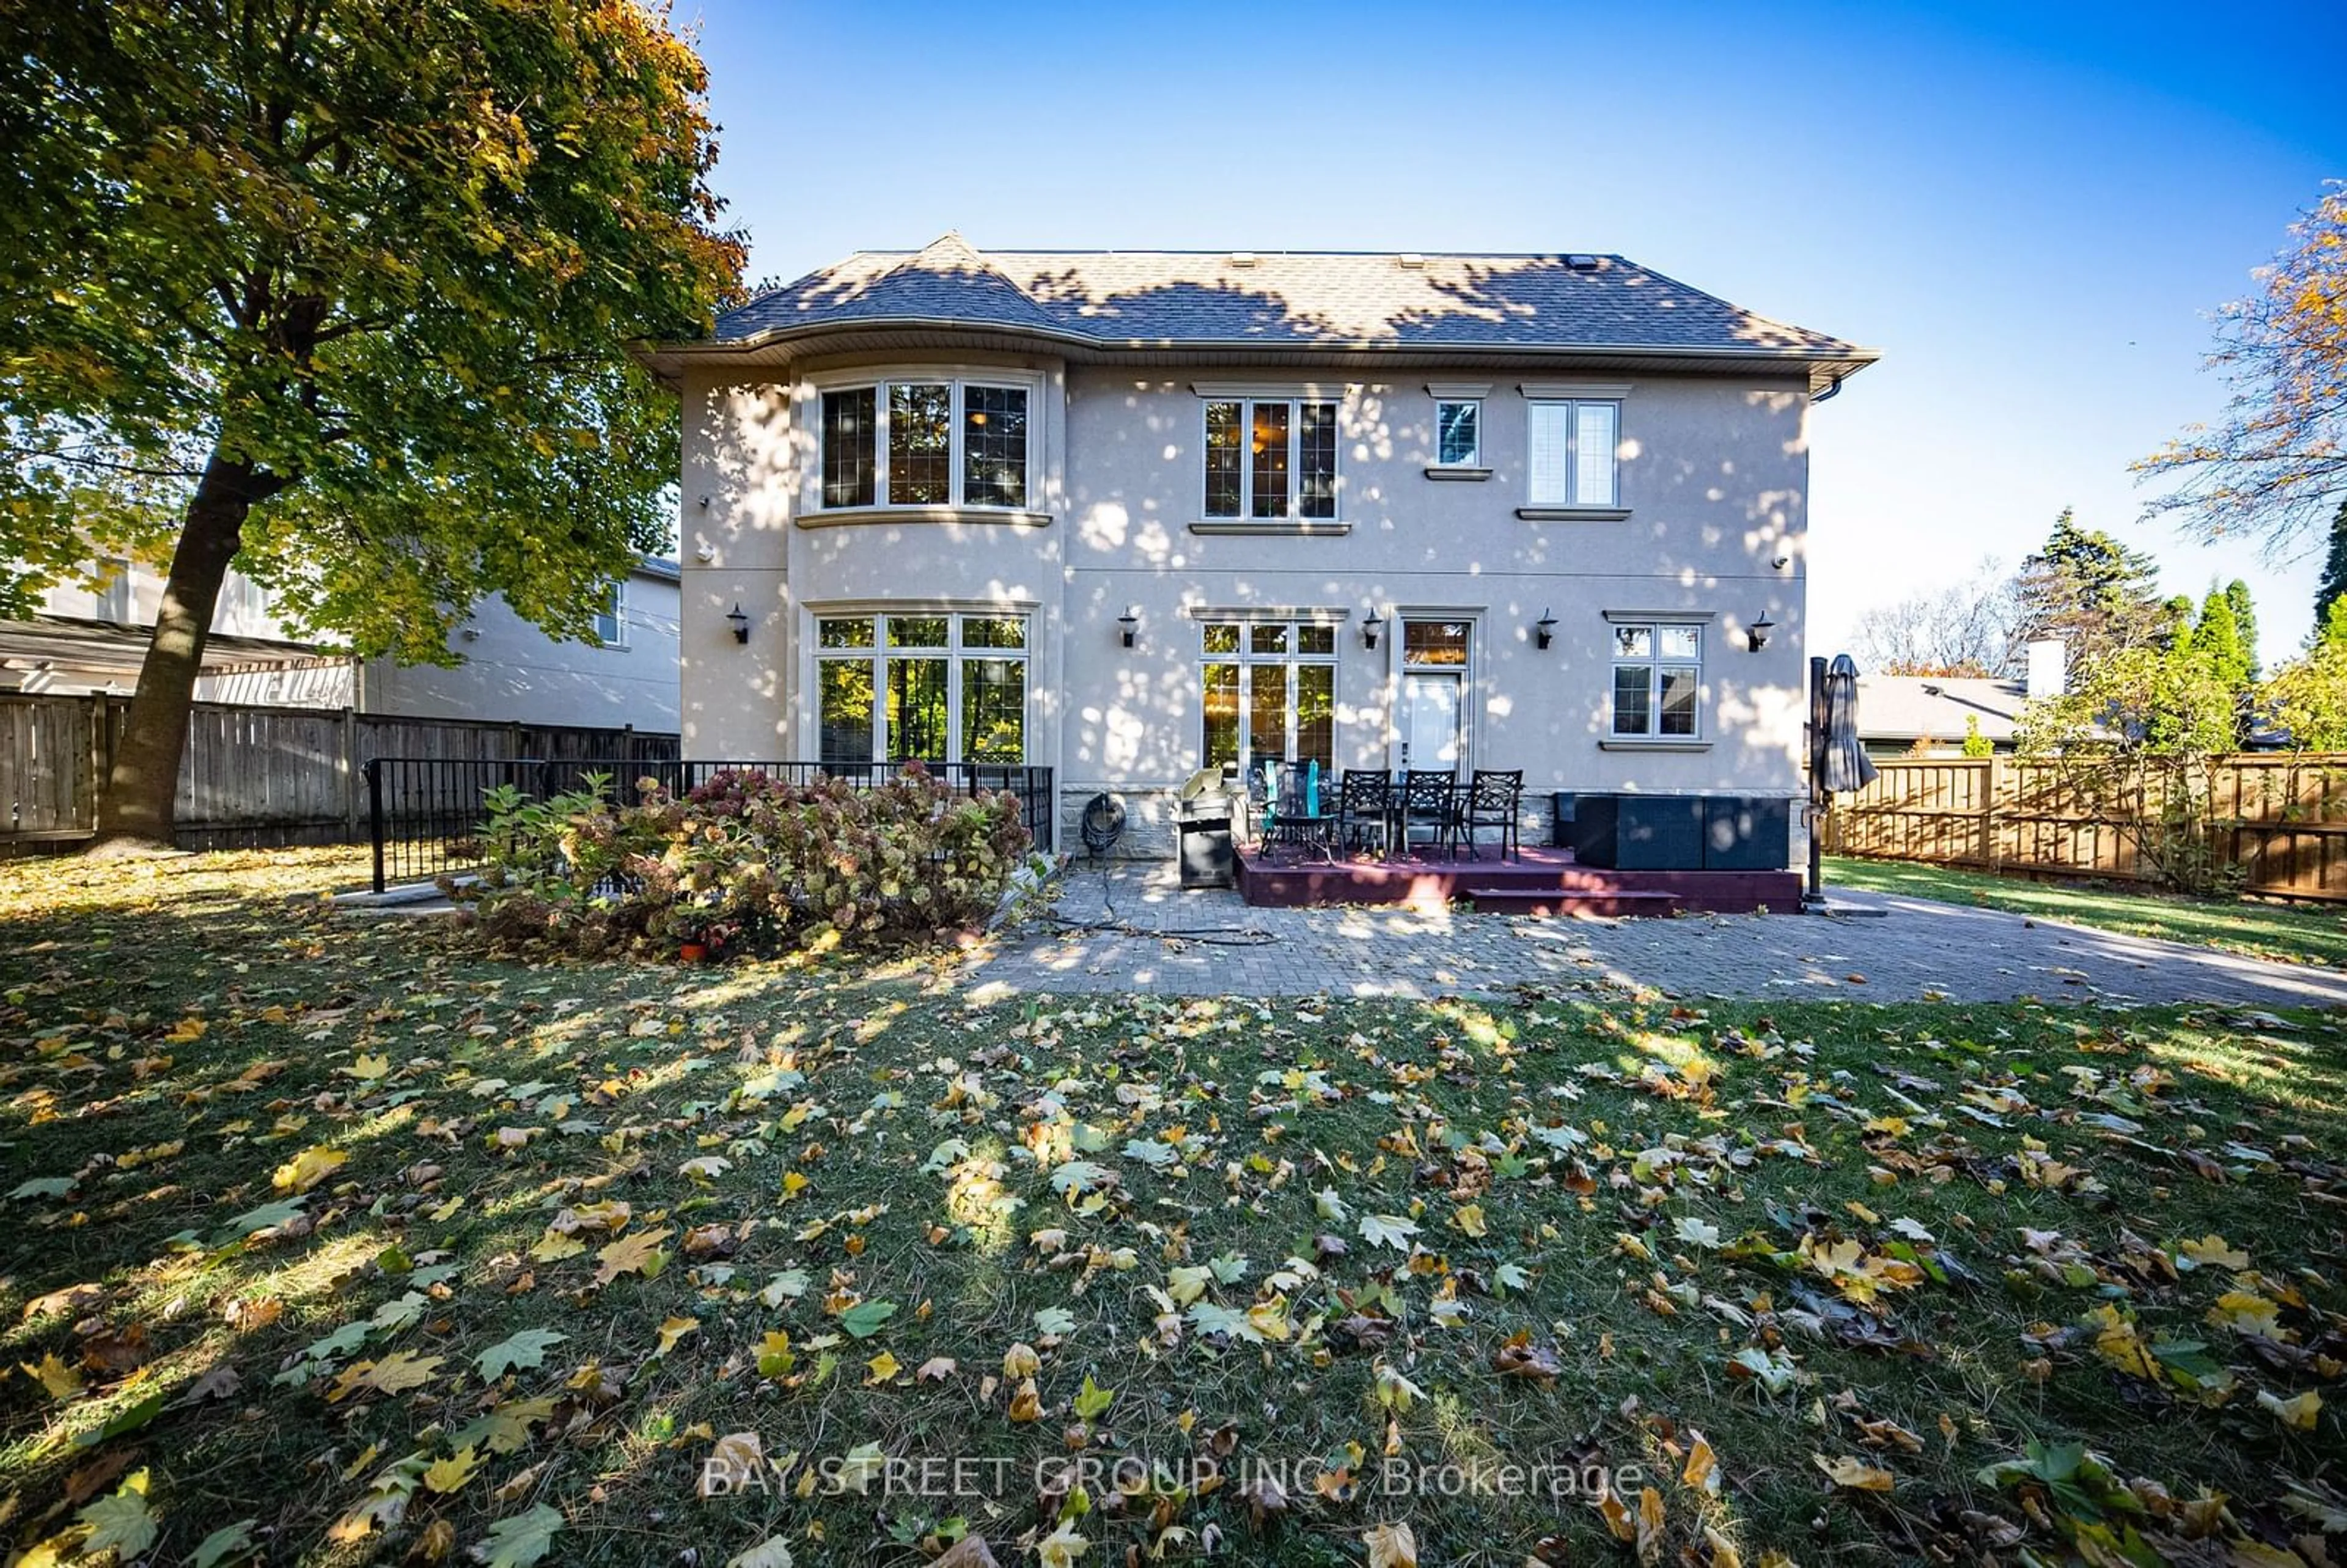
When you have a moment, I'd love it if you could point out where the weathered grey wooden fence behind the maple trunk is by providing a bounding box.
[0,695,678,854]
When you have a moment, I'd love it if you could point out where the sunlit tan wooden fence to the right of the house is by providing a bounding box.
[1824,751,2347,901]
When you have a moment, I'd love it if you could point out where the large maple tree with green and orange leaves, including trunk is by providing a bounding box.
[0,0,741,843]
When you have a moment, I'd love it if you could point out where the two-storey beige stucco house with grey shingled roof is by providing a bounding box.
[648,235,1873,852]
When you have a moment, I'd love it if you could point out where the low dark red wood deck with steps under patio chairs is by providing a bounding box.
[1240,845,1800,915]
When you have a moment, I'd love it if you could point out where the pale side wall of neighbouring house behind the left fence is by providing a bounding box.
[359,573,678,730]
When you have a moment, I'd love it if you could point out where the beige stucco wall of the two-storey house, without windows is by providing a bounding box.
[681,359,1807,859]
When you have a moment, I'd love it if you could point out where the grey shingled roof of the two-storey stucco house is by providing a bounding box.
[713,235,1873,359]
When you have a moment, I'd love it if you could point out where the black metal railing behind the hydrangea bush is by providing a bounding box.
[366,756,1056,892]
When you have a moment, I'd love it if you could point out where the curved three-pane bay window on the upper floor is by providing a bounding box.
[821,378,1028,510]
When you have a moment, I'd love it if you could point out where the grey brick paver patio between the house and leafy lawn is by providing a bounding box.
[969,866,2347,1007]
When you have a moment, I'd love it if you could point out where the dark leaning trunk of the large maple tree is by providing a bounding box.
[96,451,279,850]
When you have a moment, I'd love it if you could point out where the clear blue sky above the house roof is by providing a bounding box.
[676,0,2347,659]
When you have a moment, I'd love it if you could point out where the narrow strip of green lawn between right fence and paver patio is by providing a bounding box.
[1826,857,2347,969]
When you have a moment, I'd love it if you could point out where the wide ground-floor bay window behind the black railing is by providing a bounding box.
[814,610,1028,765]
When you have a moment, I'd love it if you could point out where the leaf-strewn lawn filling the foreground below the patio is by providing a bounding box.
[0,852,2347,1568]
